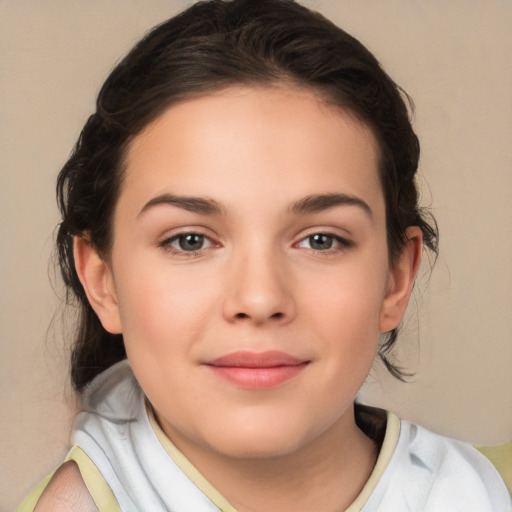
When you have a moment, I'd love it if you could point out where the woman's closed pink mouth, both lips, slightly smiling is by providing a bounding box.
[204,351,310,390]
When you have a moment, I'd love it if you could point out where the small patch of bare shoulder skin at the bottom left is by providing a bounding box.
[34,461,98,512]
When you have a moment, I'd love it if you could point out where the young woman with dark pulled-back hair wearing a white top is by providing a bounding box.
[21,0,509,512]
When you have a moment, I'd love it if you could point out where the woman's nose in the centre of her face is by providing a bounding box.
[223,246,296,325]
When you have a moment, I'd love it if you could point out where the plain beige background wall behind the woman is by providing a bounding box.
[0,0,512,511]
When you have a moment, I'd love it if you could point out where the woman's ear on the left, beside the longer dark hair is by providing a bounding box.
[73,236,122,334]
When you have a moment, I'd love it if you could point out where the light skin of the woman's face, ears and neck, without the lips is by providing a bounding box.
[75,86,421,512]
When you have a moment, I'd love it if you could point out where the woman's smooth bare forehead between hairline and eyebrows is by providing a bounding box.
[121,87,382,215]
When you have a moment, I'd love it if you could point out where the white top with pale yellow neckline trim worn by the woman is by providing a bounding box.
[66,361,512,512]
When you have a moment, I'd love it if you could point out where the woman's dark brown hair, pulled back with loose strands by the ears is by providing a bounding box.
[57,0,437,391]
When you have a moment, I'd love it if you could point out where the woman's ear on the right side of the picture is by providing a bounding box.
[379,226,423,332]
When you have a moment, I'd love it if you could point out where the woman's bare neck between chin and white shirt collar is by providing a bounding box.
[160,410,377,512]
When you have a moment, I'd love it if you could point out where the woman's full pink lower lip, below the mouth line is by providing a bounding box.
[205,363,307,390]
